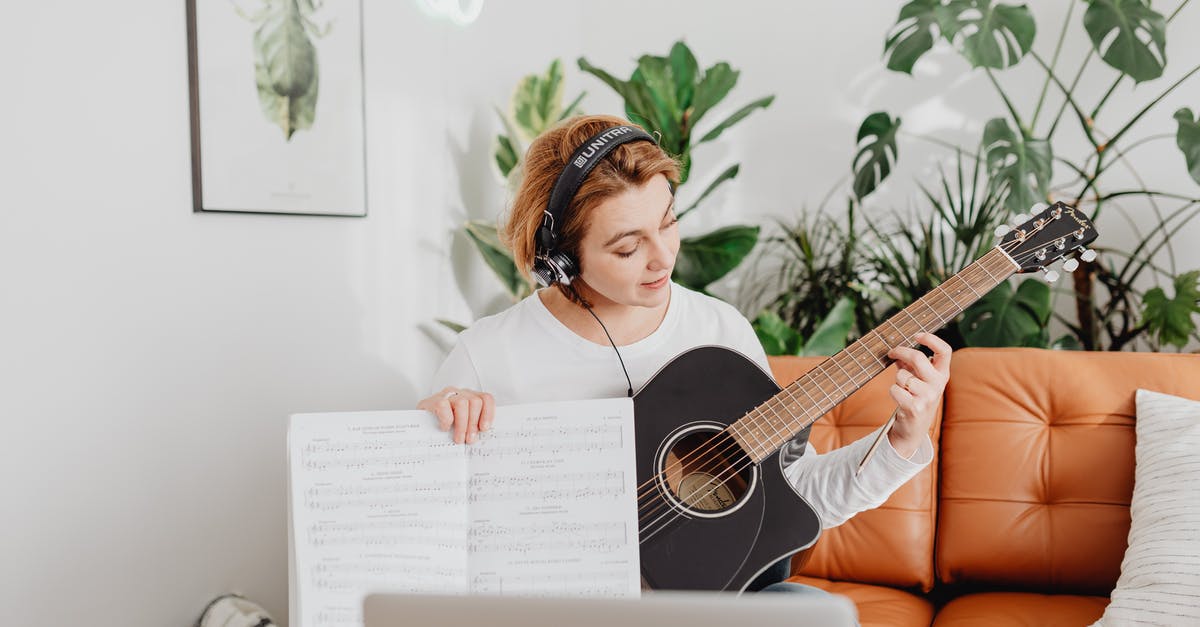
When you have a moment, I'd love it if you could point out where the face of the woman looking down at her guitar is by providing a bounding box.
[580,174,679,307]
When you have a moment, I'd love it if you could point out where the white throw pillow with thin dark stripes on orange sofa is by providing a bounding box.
[1094,382,1200,627]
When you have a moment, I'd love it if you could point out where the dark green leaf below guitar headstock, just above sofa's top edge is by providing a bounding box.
[959,280,1050,346]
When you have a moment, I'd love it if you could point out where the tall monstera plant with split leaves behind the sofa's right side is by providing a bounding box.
[853,0,1200,350]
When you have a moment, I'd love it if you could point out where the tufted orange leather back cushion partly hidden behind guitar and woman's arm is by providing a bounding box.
[769,357,941,592]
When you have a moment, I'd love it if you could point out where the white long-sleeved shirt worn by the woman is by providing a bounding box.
[430,282,934,529]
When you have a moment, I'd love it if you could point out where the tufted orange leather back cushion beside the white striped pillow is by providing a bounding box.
[936,348,1200,590]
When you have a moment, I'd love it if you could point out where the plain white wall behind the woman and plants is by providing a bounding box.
[0,0,1200,626]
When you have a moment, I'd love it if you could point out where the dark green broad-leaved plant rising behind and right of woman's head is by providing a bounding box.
[578,41,775,292]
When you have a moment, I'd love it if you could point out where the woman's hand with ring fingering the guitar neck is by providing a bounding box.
[888,333,950,458]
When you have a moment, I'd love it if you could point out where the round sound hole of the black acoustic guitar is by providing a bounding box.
[662,429,754,512]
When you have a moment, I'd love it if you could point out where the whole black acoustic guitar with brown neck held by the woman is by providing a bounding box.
[634,203,1096,591]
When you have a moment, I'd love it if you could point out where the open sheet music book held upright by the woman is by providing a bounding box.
[288,398,641,627]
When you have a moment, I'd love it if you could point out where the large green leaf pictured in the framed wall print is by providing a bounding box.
[253,2,319,141]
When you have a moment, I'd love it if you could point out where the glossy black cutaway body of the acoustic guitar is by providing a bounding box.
[634,346,821,591]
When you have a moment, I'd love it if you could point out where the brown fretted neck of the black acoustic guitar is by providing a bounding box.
[726,246,1019,462]
